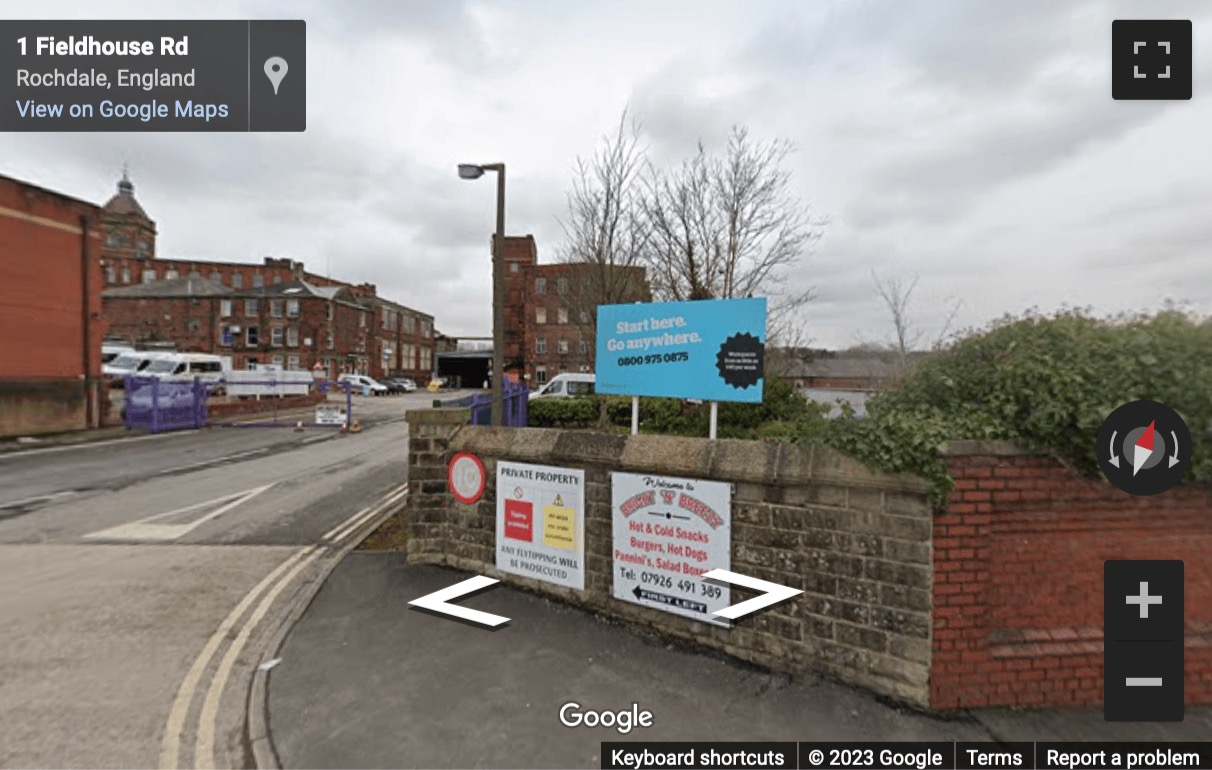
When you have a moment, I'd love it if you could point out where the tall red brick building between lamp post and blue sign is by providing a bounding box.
[505,235,652,387]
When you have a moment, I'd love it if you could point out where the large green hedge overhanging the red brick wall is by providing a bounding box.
[797,312,1212,496]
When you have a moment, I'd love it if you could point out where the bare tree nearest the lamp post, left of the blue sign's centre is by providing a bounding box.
[559,110,651,424]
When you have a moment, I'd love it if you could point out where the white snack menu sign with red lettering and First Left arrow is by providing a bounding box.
[611,473,732,626]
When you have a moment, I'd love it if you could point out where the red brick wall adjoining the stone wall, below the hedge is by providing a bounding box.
[930,454,1212,709]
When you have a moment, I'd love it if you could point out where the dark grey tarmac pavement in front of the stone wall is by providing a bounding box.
[268,552,1212,768]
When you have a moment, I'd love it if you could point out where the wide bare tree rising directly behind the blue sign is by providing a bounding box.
[645,126,823,337]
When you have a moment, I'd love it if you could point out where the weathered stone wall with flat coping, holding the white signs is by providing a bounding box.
[405,409,932,706]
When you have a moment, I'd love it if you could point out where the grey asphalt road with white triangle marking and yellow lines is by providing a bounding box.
[0,394,433,768]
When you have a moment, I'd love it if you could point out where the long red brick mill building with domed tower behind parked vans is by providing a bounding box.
[101,176,434,383]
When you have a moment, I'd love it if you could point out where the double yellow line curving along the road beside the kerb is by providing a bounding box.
[160,484,408,770]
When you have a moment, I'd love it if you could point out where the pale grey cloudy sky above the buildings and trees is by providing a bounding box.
[9,0,1212,347]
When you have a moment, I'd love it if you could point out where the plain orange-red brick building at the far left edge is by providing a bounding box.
[0,176,105,437]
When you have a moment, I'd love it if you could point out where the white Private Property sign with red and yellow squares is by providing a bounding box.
[497,461,585,591]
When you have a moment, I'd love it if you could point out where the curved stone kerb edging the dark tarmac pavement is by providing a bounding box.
[245,490,411,770]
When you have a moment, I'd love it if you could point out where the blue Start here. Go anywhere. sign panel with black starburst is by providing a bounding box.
[595,297,766,403]
